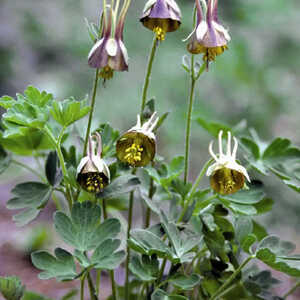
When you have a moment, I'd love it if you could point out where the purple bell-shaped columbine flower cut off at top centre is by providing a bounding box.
[140,0,181,41]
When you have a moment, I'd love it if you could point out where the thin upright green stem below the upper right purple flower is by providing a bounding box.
[183,55,196,184]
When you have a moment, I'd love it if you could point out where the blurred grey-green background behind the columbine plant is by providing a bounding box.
[0,0,300,299]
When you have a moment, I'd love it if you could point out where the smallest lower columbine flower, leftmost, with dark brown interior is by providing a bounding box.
[77,133,110,193]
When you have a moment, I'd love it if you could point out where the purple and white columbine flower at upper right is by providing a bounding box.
[187,0,230,67]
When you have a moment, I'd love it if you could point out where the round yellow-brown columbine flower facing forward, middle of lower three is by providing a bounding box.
[116,112,158,167]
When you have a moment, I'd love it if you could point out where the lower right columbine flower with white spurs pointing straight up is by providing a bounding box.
[206,130,250,195]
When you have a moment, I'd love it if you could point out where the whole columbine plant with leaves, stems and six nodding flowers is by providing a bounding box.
[0,0,300,300]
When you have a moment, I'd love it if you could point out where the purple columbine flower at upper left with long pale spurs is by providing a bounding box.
[88,0,131,80]
